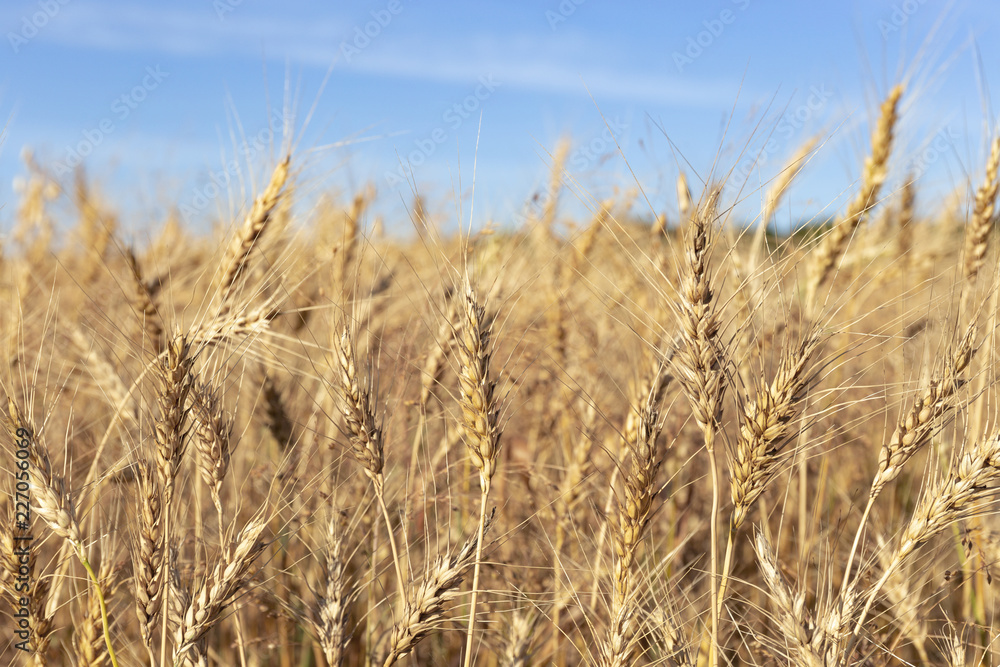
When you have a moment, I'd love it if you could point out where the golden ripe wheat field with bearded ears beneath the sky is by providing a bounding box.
[0,86,1000,667]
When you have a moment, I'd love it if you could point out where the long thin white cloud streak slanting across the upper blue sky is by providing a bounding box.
[29,3,736,107]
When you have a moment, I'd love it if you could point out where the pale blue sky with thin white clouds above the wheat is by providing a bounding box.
[0,0,1000,237]
